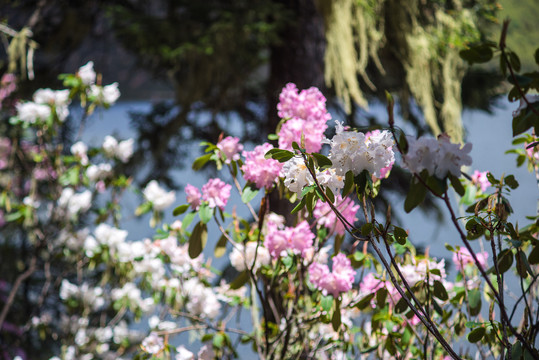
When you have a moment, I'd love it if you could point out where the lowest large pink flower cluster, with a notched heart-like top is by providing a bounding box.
[309,253,356,297]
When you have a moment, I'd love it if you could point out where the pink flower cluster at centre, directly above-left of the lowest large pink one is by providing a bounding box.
[264,220,315,258]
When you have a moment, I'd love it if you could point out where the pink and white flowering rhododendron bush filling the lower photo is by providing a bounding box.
[0,21,539,360]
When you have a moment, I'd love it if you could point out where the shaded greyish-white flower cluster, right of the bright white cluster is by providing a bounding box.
[403,134,472,179]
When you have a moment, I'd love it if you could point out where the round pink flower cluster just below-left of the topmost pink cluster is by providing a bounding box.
[241,143,283,189]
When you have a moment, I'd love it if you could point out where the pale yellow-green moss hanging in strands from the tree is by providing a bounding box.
[318,0,488,142]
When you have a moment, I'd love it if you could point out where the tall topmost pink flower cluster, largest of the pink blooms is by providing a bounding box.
[277,83,331,152]
